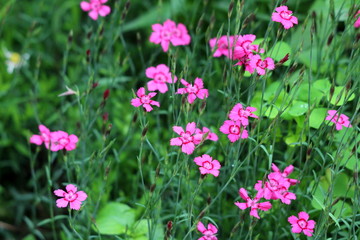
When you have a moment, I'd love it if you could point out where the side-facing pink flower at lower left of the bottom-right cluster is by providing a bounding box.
[235,188,272,219]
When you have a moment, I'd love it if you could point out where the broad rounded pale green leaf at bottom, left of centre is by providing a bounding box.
[94,202,135,235]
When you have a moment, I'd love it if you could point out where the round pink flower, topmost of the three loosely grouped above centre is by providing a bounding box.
[145,64,177,93]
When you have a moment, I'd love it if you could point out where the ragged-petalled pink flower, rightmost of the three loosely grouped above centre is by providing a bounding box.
[176,78,209,104]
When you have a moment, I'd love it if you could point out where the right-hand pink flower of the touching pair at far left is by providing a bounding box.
[50,131,79,152]
